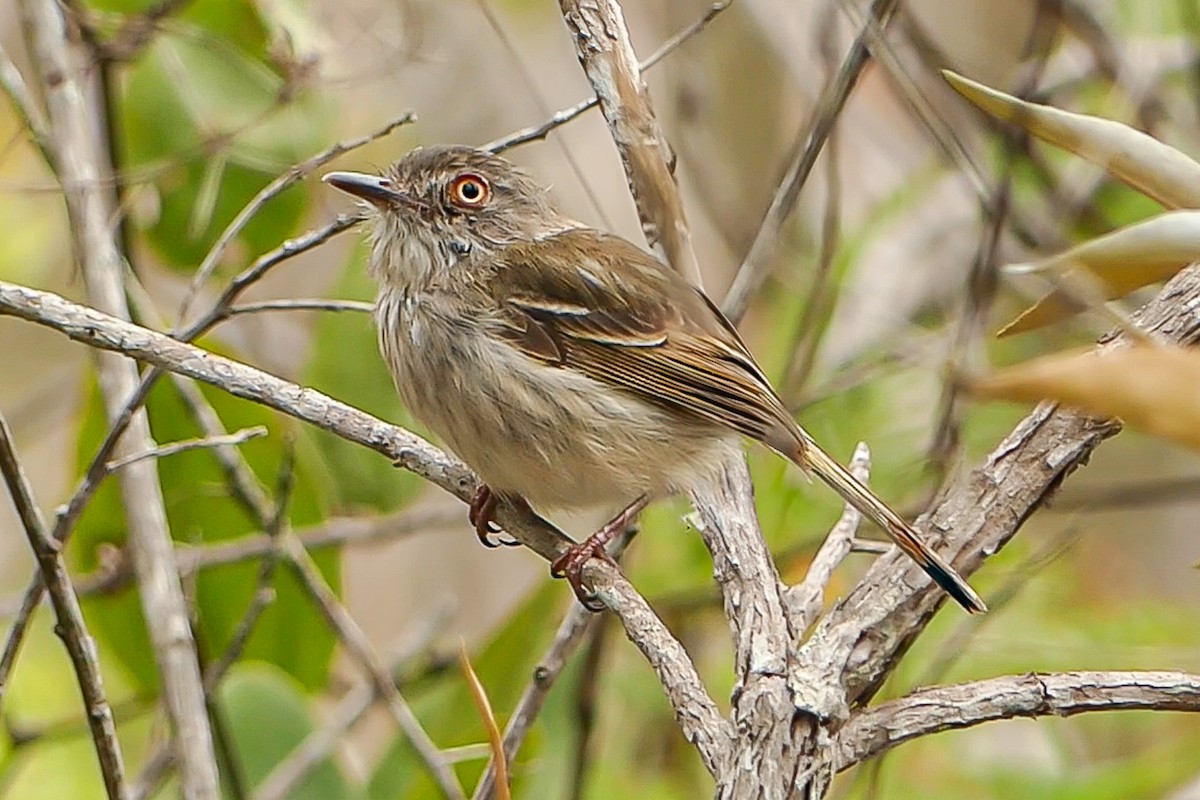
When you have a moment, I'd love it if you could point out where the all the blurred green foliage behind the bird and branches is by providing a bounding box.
[0,0,1200,800]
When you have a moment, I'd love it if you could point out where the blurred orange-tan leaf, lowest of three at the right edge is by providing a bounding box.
[971,345,1200,451]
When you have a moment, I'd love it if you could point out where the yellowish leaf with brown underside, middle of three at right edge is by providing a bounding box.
[997,211,1200,336]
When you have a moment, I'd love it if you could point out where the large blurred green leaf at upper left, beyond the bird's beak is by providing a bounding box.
[121,15,331,270]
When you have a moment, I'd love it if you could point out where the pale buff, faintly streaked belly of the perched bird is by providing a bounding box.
[385,303,740,509]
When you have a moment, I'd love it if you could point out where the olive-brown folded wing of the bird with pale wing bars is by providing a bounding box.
[492,229,794,444]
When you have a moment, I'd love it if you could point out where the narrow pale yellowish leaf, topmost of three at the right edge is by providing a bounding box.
[942,70,1200,209]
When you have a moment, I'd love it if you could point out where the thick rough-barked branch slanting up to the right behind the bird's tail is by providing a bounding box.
[800,266,1200,716]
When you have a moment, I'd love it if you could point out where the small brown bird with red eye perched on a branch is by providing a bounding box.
[324,146,986,612]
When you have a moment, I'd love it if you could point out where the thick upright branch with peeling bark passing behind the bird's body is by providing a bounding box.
[560,0,804,798]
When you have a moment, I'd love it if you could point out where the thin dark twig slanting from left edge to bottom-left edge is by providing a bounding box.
[0,415,128,800]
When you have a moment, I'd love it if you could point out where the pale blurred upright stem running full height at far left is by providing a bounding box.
[22,0,220,800]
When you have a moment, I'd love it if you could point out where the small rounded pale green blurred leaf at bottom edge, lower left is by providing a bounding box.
[217,663,362,800]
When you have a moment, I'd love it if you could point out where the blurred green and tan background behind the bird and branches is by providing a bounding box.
[0,0,1200,800]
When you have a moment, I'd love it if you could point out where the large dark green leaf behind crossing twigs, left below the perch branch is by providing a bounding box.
[67,357,340,692]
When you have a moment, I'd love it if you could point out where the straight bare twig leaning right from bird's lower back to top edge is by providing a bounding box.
[721,0,896,321]
